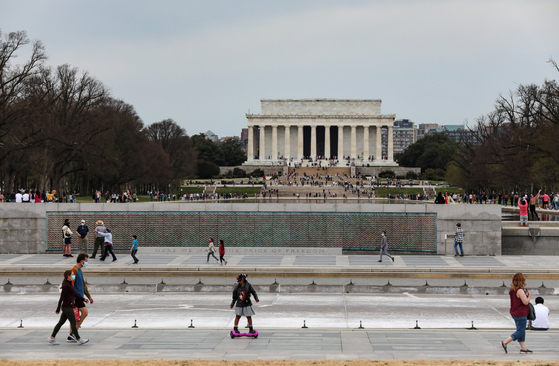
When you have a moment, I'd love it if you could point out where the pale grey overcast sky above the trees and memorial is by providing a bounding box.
[0,0,559,137]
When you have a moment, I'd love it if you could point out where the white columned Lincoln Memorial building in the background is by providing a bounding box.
[243,99,397,166]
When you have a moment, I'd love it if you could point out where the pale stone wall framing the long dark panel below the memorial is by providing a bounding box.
[0,202,501,255]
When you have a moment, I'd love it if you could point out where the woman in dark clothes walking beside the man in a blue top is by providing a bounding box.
[47,269,89,345]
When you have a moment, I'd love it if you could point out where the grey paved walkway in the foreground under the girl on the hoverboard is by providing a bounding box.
[0,328,559,362]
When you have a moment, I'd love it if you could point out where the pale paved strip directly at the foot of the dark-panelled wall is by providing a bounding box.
[0,253,559,271]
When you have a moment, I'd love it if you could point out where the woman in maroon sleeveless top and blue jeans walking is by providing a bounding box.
[501,273,532,353]
